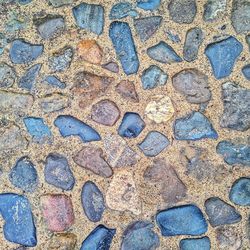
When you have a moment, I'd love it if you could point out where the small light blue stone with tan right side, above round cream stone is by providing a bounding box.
[141,65,168,89]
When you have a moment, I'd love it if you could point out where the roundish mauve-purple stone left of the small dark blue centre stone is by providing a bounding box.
[91,99,120,126]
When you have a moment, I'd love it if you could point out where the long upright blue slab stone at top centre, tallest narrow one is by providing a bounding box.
[109,21,140,75]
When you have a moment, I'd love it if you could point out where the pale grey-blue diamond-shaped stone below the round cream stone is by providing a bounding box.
[138,131,170,157]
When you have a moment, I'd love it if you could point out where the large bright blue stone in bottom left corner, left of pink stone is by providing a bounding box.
[0,193,37,247]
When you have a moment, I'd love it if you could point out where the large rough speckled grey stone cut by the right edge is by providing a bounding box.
[220,82,250,131]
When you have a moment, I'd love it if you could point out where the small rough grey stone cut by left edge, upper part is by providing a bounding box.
[0,63,17,88]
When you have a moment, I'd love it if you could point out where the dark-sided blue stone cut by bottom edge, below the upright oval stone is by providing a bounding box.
[80,225,116,250]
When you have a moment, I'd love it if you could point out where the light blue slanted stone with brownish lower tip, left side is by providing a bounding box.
[23,117,52,143]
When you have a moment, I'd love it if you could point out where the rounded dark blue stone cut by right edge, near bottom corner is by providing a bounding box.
[229,177,250,206]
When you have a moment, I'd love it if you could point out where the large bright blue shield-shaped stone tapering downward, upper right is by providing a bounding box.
[205,36,243,79]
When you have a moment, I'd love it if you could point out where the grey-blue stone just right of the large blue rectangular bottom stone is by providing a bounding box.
[205,197,241,227]
